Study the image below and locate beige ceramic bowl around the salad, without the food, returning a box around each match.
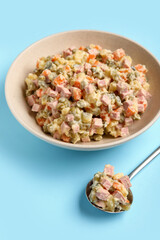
[5,30,160,150]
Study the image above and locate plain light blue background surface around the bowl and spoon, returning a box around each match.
[0,0,160,240]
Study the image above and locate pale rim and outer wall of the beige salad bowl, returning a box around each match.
[5,29,160,151]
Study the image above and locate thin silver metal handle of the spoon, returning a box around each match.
[128,147,160,180]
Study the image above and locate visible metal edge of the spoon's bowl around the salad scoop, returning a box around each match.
[86,179,133,213]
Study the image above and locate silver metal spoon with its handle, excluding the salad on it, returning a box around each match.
[86,147,160,213]
